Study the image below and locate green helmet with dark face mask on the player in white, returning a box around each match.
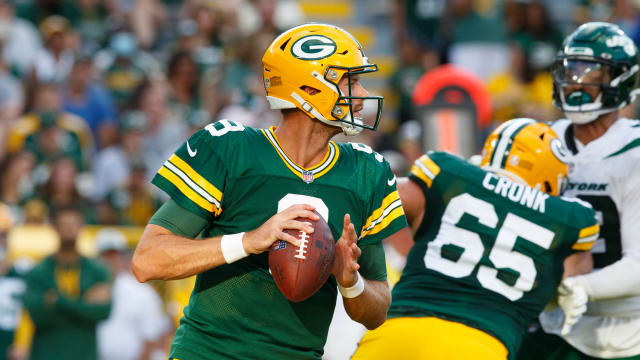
[552,22,640,124]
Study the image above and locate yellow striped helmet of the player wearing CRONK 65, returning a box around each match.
[480,118,569,195]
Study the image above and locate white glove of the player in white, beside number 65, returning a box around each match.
[558,276,589,335]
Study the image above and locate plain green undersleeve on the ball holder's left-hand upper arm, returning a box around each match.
[149,199,208,239]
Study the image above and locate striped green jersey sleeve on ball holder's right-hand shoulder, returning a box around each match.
[352,144,407,246]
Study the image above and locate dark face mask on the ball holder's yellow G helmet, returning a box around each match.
[324,64,384,130]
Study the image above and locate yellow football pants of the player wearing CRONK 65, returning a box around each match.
[351,317,508,360]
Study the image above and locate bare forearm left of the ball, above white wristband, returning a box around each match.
[131,224,226,282]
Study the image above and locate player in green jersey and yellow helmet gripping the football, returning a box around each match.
[132,24,408,360]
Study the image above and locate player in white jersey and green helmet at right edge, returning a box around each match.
[519,22,640,359]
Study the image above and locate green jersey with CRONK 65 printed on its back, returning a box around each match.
[389,152,598,357]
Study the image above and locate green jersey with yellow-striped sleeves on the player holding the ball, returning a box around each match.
[153,120,407,360]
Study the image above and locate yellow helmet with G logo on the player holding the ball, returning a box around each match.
[262,24,382,135]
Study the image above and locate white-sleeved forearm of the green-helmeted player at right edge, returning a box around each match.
[580,254,640,300]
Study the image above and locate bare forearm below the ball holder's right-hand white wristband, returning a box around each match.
[343,279,391,330]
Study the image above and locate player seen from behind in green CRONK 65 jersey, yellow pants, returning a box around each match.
[353,119,598,360]
